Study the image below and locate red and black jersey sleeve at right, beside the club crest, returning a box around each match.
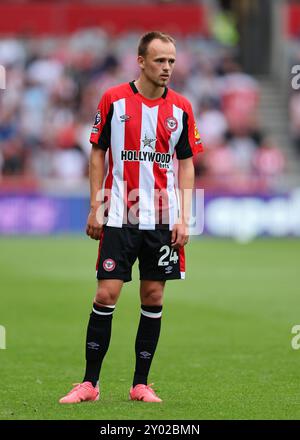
[175,105,203,160]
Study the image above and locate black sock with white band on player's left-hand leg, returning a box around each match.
[83,303,115,386]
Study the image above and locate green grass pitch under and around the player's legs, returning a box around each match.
[0,237,300,420]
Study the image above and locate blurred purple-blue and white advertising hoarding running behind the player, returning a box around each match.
[0,189,300,241]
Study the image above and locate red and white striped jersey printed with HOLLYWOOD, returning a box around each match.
[90,82,202,230]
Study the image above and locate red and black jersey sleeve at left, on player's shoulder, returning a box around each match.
[90,93,113,151]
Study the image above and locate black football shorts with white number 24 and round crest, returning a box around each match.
[96,226,185,282]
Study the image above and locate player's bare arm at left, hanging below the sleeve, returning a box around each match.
[86,144,105,240]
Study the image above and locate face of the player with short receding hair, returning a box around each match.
[138,39,176,87]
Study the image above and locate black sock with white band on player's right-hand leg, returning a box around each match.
[133,305,162,386]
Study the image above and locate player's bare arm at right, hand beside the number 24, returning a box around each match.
[172,157,195,248]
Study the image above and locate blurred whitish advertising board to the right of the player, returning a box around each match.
[204,189,300,241]
